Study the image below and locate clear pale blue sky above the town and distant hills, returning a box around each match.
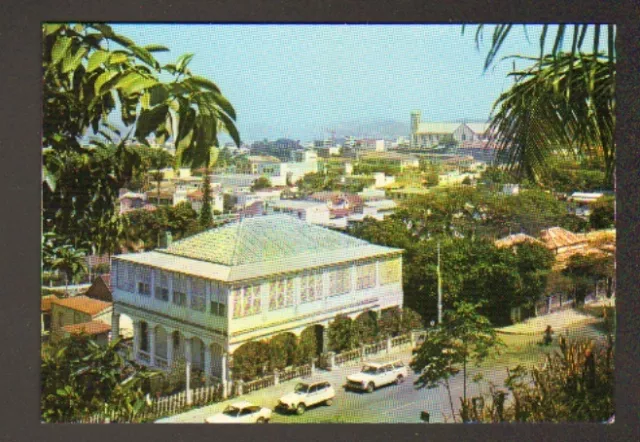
[113,24,556,142]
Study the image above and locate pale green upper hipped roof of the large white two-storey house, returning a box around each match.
[158,215,380,266]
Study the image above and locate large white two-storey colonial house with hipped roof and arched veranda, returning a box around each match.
[112,215,403,387]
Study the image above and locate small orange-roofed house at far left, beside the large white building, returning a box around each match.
[51,295,113,343]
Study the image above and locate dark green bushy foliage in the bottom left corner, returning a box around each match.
[40,335,153,422]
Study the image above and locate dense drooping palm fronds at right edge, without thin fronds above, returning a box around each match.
[491,53,615,186]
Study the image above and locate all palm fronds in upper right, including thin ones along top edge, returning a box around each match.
[463,24,616,185]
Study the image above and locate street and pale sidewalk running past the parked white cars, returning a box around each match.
[156,312,603,423]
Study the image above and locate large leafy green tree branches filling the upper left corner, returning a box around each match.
[42,23,240,253]
